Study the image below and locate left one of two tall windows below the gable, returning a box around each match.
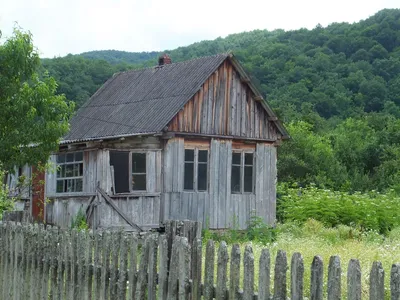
[183,149,208,192]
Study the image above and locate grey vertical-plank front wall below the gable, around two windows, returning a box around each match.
[162,138,276,229]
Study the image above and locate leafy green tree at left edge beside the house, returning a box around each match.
[0,29,74,169]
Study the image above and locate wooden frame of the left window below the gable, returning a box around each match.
[183,146,210,193]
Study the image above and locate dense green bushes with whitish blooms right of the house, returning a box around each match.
[278,185,400,234]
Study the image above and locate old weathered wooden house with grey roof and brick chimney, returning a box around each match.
[7,54,287,229]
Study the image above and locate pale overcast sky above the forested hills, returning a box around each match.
[0,0,400,57]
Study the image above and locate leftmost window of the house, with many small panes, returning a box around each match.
[56,152,83,193]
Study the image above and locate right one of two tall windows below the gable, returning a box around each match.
[231,152,254,193]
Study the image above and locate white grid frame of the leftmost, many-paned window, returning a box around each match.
[55,151,85,195]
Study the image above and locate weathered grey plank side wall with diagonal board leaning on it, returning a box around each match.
[46,137,162,228]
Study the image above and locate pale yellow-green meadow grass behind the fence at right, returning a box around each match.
[204,220,400,299]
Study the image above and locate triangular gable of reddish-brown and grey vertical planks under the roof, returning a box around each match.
[168,60,278,140]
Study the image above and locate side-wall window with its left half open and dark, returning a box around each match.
[110,151,147,193]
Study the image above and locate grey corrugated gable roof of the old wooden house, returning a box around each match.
[61,53,287,144]
